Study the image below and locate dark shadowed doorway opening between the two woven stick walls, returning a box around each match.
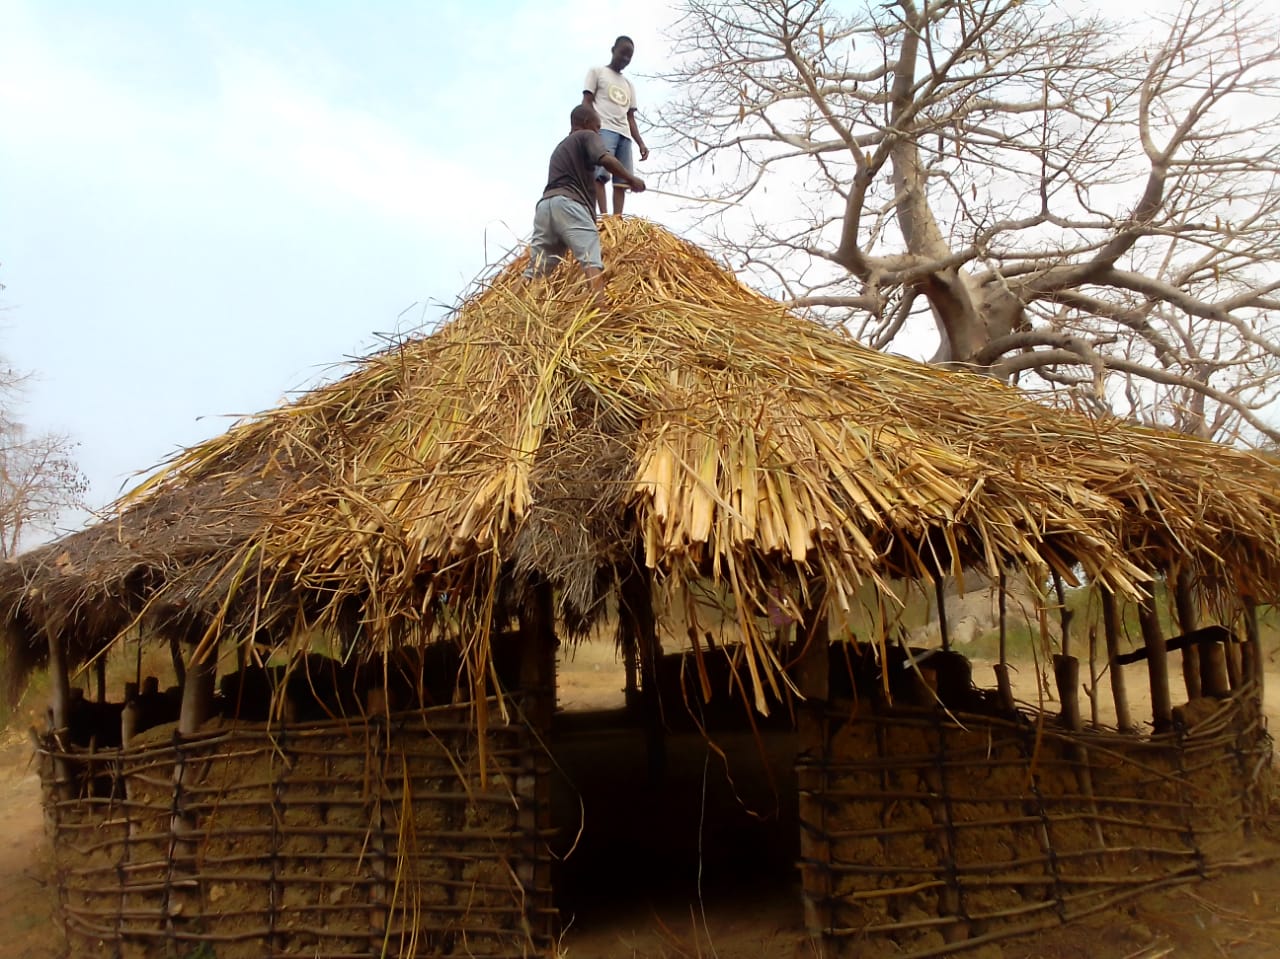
[552,711,801,928]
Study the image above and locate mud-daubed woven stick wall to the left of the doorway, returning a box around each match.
[41,705,554,959]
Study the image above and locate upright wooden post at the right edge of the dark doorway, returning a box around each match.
[795,599,833,949]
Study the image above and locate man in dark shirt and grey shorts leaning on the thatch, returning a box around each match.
[525,105,644,300]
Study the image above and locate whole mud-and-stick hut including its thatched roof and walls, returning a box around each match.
[0,219,1280,956]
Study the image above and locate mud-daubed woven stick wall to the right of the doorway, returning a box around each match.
[799,689,1271,959]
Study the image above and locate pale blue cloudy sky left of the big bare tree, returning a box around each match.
[0,0,696,530]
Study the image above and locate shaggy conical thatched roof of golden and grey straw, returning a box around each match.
[0,219,1280,696]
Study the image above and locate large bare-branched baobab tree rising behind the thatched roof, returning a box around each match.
[662,0,1280,439]
